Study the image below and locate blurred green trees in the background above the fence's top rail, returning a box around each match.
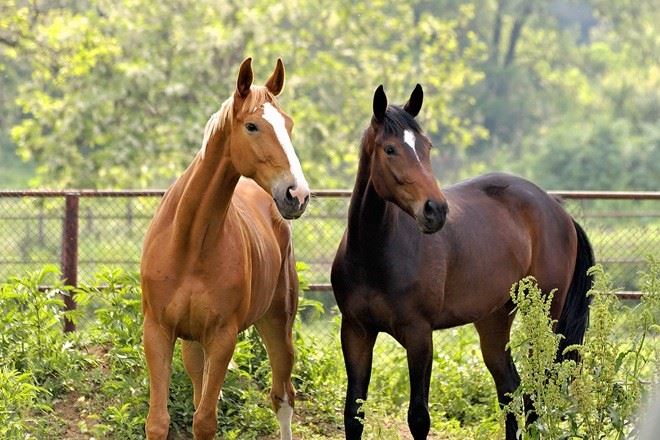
[0,0,660,189]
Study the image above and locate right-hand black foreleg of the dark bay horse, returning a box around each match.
[404,328,433,440]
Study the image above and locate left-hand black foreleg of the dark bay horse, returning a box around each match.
[341,319,377,440]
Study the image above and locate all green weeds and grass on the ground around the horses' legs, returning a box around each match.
[0,259,660,439]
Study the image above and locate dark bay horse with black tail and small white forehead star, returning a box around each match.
[332,85,593,440]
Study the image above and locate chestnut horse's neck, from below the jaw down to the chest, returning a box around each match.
[173,124,240,251]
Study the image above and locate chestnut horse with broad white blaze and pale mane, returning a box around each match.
[141,58,309,439]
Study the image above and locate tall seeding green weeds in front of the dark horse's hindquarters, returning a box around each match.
[507,259,660,439]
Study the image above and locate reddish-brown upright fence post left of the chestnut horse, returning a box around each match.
[60,193,79,332]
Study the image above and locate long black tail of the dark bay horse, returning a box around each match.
[555,220,594,362]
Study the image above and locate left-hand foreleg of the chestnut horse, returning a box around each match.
[144,315,175,440]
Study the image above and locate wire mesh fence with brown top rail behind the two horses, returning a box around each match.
[0,190,660,312]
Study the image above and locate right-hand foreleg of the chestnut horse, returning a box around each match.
[193,325,238,440]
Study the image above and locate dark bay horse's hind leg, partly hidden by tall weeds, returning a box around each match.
[474,302,535,440]
